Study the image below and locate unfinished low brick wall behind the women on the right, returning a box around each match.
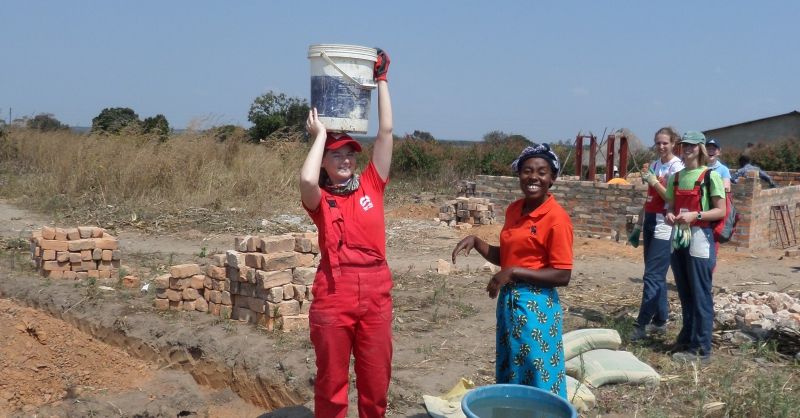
[475,172,800,249]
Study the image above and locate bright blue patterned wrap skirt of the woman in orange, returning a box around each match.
[496,283,567,399]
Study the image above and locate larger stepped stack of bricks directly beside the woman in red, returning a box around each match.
[155,233,319,331]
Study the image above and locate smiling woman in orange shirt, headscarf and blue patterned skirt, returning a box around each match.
[452,144,573,399]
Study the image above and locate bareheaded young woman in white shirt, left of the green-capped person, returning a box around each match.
[630,127,683,341]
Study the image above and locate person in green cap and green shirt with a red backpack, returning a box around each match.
[665,131,725,363]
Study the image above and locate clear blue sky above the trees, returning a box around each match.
[0,0,800,141]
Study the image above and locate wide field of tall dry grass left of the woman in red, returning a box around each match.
[0,130,307,229]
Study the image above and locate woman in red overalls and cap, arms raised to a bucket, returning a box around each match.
[300,49,393,418]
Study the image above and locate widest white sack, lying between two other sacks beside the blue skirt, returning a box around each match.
[566,349,661,387]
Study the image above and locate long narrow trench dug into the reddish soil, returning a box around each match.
[7,298,304,411]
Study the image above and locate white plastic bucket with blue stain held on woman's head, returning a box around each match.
[308,44,378,134]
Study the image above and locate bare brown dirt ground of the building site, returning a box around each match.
[0,201,800,418]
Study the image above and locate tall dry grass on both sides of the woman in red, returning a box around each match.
[0,129,458,232]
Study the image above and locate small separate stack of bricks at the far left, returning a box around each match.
[30,226,121,280]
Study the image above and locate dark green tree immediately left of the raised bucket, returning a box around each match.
[247,91,309,141]
